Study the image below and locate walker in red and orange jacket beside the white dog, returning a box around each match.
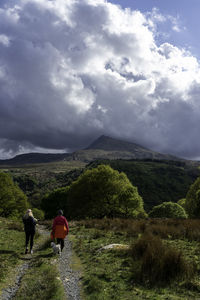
[51,209,69,251]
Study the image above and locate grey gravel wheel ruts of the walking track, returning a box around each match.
[0,225,82,300]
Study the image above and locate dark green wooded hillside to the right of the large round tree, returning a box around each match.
[88,160,200,212]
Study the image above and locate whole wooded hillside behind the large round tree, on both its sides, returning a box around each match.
[6,156,200,211]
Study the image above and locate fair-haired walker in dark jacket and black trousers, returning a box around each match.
[22,209,37,254]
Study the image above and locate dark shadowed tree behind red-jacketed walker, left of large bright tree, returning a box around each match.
[41,187,69,219]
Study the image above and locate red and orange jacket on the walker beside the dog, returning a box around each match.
[52,216,69,239]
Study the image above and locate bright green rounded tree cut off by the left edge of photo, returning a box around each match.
[0,173,28,217]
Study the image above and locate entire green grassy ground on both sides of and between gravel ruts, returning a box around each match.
[0,218,200,300]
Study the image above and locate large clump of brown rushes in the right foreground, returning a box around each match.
[130,234,195,286]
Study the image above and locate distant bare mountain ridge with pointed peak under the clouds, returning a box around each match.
[0,135,189,166]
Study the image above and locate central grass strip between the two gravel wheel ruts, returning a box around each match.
[14,238,65,300]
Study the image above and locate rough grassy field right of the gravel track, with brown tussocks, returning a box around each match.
[71,219,200,300]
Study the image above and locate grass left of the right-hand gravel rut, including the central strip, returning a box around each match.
[0,218,65,300]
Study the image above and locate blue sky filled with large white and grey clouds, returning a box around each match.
[0,0,200,159]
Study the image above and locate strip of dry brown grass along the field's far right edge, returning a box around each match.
[76,218,200,241]
